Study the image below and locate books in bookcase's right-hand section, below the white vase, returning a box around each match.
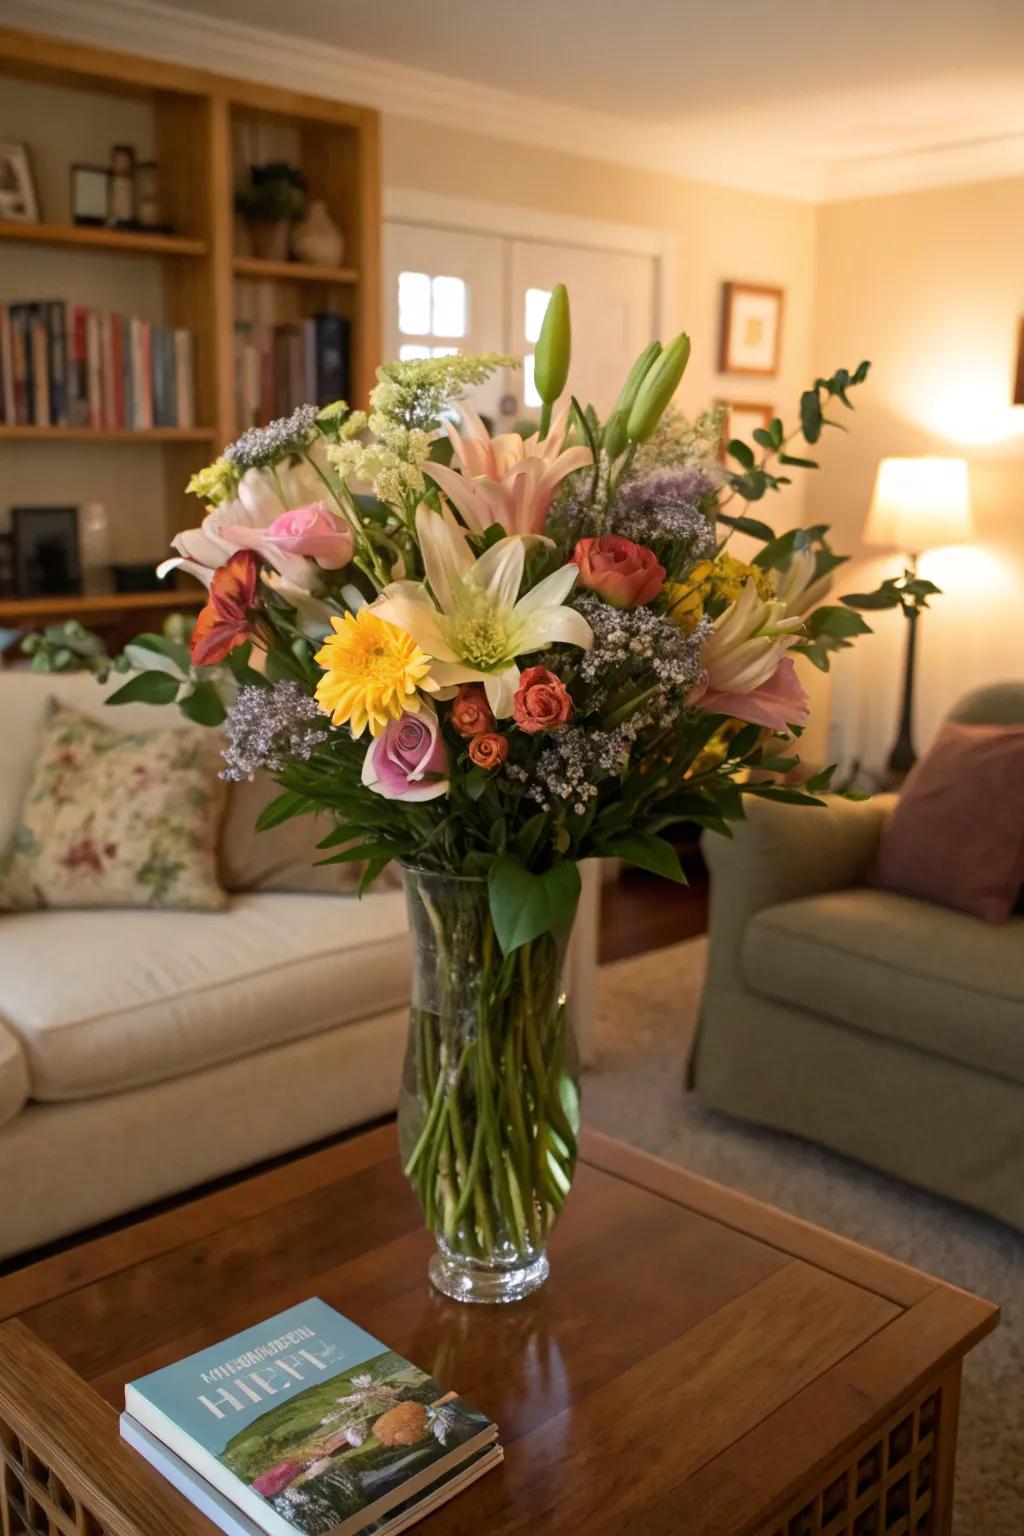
[235,315,350,427]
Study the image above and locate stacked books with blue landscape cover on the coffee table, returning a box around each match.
[121,1299,502,1536]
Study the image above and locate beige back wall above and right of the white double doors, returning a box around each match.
[382,117,815,527]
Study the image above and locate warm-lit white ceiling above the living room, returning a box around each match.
[16,0,1024,200]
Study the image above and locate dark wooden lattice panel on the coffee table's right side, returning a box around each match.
[758,1376,958,1536]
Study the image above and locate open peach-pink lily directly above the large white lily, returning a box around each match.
[422,401,593,533]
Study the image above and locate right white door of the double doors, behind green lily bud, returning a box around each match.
[507,240,656,419]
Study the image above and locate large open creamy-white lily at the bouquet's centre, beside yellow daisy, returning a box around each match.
[373,505,594,720]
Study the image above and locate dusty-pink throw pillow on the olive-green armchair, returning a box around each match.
[874,720,1024,923]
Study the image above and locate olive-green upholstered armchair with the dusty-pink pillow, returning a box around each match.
[691,684,1024,1229]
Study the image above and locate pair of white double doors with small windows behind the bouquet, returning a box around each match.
[384,221,657,422]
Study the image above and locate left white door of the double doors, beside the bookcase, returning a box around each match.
[382,223,508,416]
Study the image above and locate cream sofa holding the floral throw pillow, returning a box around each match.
[0,671,599,1258]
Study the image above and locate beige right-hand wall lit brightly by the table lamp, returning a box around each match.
[808,180,1024,763]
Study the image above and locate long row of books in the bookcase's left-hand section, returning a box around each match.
[0,300,195,430]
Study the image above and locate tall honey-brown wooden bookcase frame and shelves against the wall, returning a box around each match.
[0,28,381,621]
